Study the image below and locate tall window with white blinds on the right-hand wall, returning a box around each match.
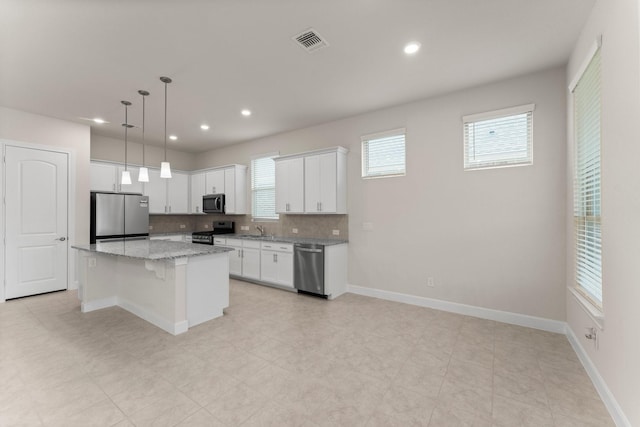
[573,49,602,307]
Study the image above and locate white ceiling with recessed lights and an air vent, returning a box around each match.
[0,0,595,152]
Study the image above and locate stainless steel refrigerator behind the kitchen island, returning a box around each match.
[90,191,149,243]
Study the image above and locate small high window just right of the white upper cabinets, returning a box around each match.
[361,129,406,178]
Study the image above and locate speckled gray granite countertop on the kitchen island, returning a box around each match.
[71,239,232,261]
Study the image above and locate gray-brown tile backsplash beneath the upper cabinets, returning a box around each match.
[149,215,349,239]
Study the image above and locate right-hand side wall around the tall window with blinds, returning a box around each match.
[566,0,640,425]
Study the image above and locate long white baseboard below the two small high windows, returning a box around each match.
[347,285,566,334]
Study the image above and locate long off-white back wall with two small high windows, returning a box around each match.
[195,68,566,321]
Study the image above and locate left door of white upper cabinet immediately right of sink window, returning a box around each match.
[275,157,304,213]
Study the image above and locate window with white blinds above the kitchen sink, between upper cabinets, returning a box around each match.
[251,154,278,219]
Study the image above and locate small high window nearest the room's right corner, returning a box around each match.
[462,104,535,170]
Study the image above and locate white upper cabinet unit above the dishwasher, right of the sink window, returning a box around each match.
[275,147,347,214]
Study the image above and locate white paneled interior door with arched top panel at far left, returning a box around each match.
[5,146,69,299]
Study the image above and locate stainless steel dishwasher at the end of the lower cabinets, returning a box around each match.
[293,243,324,296]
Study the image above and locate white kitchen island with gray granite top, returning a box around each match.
[72,239,231,335]
